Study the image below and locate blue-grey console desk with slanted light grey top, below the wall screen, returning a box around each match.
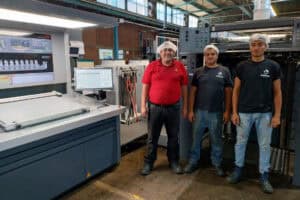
[0,92,125,199]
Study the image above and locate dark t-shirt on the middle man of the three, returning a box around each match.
[192,66,232,112]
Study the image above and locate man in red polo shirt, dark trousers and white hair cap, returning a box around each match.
[141,41,188,175]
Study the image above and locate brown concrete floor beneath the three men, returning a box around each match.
[59,146,300,200]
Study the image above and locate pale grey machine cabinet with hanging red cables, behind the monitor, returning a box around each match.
[96,60,149,145]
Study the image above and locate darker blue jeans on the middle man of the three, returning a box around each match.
[189,109,223,166]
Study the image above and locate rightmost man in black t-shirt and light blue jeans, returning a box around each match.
[228,34,282,193]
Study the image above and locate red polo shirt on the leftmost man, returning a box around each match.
[142,60,188,105]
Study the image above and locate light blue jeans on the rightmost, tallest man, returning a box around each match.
[235,113,272,174]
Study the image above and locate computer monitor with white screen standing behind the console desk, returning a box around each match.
[74,68,113,91]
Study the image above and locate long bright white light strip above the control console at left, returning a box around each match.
[0,8,96,29]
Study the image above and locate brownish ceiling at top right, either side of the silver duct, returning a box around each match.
[166,0,300,24]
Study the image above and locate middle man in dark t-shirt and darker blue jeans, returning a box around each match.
[184,45,232,176]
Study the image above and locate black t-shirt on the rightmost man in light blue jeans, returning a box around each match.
[236,59,281,113]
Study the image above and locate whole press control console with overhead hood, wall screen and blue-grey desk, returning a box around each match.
[0,0,125,200]
